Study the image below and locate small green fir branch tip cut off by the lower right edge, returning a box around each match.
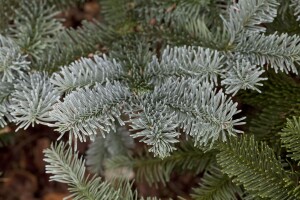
[280,117,300,165]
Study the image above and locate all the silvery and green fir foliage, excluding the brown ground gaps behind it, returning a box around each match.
[0,0,300,200]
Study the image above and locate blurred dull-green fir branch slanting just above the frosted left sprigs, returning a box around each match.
[33,21,117,72]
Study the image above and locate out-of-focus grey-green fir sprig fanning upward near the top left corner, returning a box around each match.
[10,0,63,60]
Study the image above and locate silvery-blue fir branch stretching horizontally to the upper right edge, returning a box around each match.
[234,33,300,74]
